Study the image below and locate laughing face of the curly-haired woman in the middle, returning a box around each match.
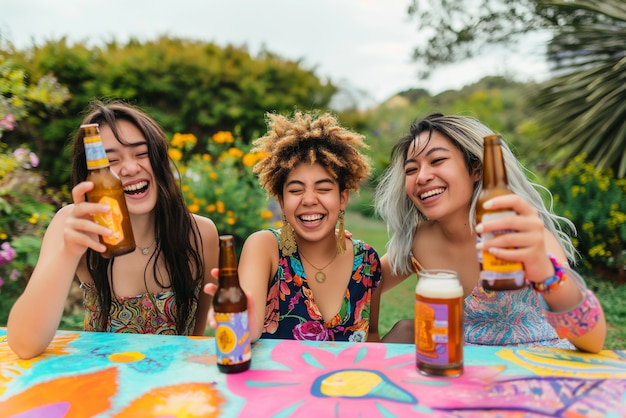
[280,163,350,241]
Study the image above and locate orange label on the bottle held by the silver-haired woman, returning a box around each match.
[478,211,524,286]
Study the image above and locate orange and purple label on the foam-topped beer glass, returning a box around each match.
[415,301,450,365]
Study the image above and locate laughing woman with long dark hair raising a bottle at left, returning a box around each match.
[7,101,219,358]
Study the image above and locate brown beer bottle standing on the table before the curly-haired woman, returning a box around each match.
[213,235,252,373]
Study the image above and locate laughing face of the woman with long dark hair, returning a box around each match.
[100,120,157,214]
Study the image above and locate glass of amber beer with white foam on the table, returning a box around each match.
[415,270,463,377]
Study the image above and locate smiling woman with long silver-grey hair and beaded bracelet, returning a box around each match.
[372,114,606,352]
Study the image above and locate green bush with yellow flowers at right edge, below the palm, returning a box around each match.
[547,155,626,280]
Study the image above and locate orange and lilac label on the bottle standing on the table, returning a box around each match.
[215,311,252,366]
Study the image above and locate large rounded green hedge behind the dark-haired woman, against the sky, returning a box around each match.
[0,36,337,187]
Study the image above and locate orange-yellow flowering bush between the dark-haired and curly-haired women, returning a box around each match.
[170,126,278,245]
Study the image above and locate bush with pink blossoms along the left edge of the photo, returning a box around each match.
[0,55,68,325]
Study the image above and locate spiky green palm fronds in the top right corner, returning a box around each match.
[536,0,626,178]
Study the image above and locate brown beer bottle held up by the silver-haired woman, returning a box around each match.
[476,135,524,290]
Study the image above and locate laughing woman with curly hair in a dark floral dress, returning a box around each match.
[207,112,381,341]
